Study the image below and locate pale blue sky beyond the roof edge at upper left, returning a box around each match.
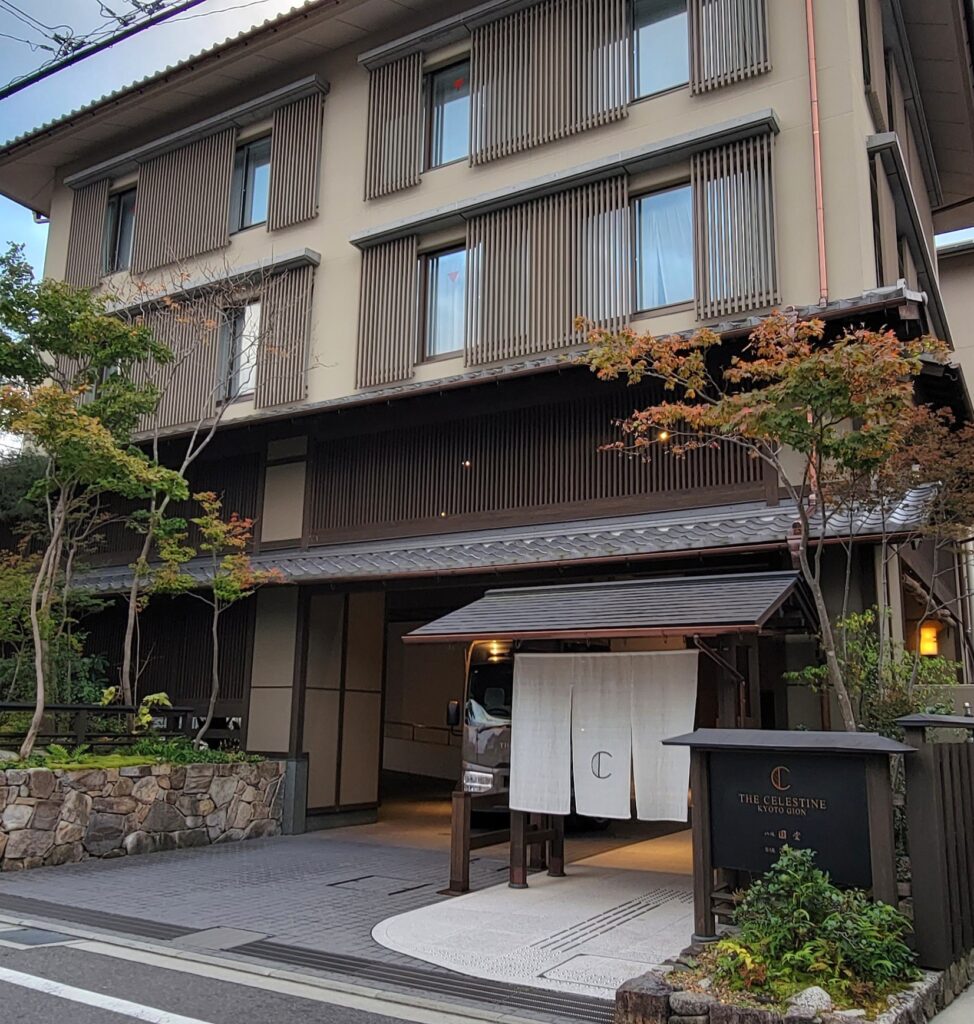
[0,0,301,274]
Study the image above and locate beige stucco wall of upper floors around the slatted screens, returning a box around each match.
[36,0,905,419]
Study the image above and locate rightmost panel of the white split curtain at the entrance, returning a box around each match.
[632,650,700,821]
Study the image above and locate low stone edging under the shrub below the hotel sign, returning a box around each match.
[615,953,974,1024]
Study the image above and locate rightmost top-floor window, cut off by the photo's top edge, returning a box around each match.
[633,0,690,99]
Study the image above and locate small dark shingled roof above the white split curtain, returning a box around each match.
[403,572,799,643]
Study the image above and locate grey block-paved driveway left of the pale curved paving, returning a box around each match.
[0,833,507,966]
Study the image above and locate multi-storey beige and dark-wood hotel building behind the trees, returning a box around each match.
[0,0,974,814]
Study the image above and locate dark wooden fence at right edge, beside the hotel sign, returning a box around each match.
[899,715,974,970]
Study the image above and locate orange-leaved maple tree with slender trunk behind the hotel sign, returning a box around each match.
[579,311,974,730]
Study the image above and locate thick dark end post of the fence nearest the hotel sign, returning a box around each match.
[904,727,954,971]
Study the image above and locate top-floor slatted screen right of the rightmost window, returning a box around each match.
[689,0,771,93]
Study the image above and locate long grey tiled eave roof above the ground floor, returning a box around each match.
[84,493,923,593]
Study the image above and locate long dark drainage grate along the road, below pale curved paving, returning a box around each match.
[234,941,615,1024]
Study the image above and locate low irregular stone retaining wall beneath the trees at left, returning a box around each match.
[0,761,284,871]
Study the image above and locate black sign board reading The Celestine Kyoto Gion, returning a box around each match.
[709,750,872,889]
